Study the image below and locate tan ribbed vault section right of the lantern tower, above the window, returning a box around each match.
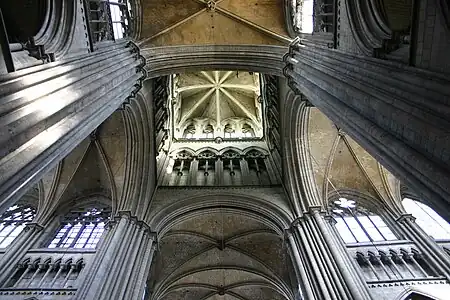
[308,108,401,211]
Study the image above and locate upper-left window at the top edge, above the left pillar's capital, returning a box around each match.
[86,0,131,43]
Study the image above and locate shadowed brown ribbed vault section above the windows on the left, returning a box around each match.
[31,111,126,222]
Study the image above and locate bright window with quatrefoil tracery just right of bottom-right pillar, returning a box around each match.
[332,197,397,243]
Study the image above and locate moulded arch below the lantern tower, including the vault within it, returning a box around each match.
[149,191,294,300]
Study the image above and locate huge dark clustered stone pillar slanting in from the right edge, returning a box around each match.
[284,40,450,221]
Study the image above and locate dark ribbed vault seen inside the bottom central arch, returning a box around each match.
[149,209,293,300]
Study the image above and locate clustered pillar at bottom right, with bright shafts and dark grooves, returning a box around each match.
[292,208,372,300]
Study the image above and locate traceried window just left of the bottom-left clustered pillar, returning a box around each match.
[48,207,111,249]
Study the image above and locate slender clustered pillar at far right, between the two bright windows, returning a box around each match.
[396,214,450,280]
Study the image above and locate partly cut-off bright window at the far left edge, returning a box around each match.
[0,204,36,248]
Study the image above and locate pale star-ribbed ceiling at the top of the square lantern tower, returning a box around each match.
[172,71,263,138]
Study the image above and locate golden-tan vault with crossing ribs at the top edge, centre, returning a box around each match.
[140,0,290,48]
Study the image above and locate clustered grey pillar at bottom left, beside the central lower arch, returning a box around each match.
[75,212,156,300]
